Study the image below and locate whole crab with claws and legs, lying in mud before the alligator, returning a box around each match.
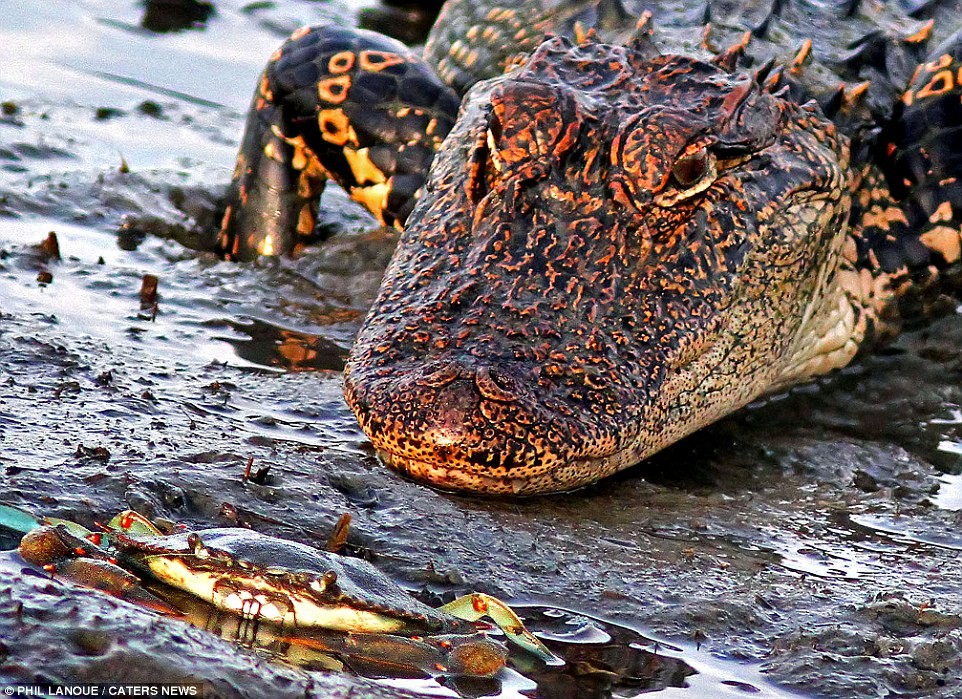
[0,505,563,675]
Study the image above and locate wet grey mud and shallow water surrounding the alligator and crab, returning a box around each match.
[0,0,962,699]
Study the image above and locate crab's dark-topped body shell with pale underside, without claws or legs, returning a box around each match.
[111,528,468,634]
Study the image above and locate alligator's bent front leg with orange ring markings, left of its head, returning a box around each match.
[217,26,459,260]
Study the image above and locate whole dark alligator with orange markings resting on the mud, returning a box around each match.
[219,0,962,495]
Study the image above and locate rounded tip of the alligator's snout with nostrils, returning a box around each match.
[345,361,608,494]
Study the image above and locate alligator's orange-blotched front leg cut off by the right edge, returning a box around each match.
[849,31,962,340]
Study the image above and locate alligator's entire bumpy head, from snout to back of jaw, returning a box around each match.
[345,38,858,493]
